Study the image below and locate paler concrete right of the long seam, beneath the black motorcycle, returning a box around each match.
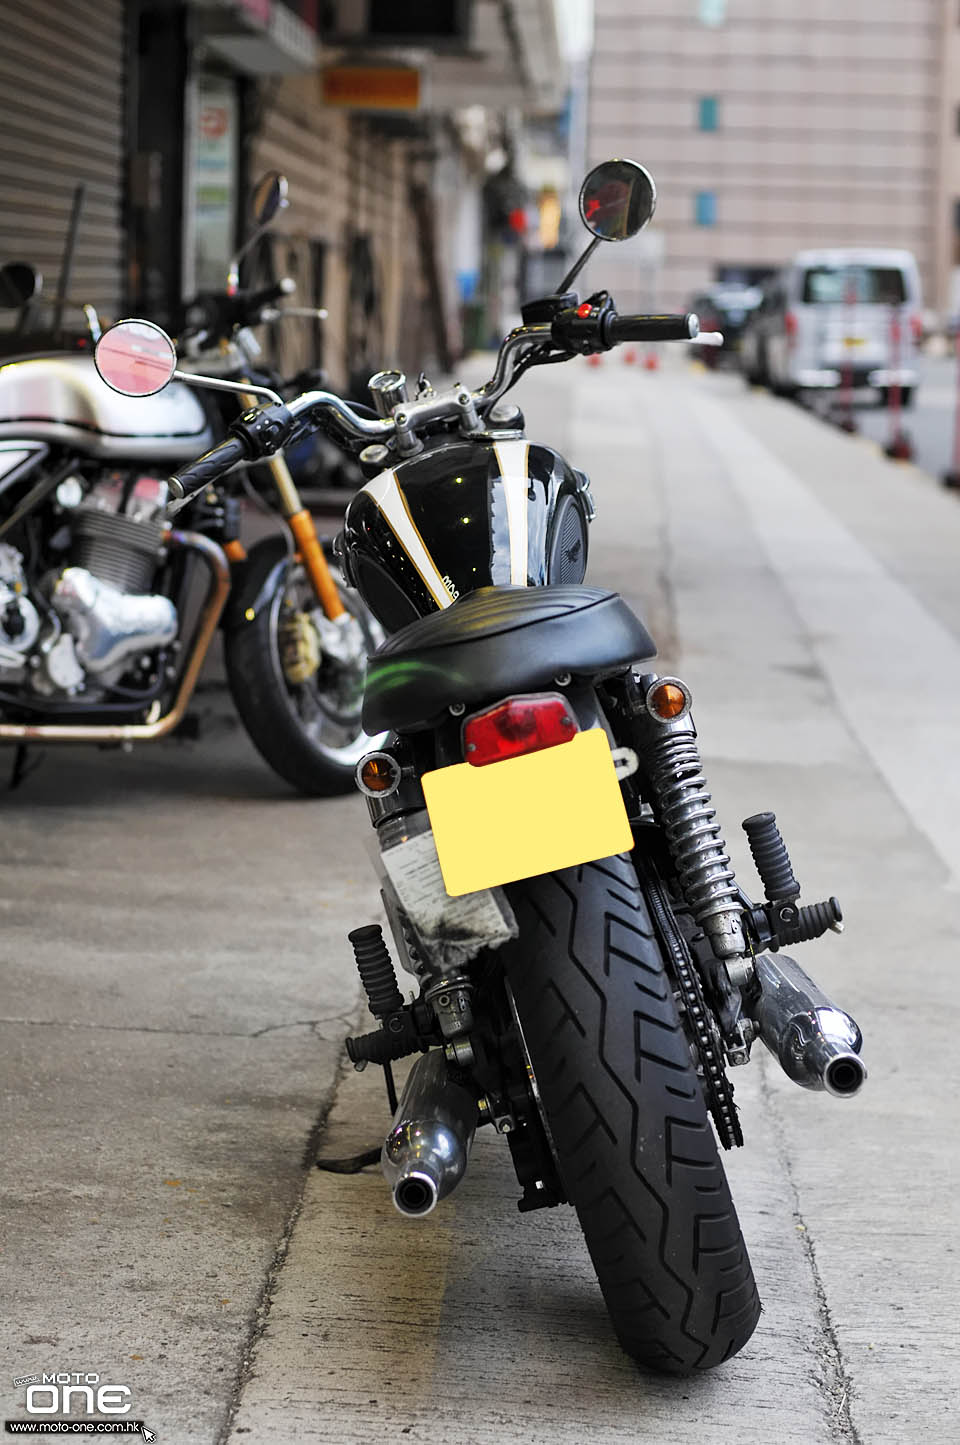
[222,360,960,1445]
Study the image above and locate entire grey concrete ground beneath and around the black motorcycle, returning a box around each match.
[0,358,960,1445]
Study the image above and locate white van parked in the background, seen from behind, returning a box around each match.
[742,247,922,406]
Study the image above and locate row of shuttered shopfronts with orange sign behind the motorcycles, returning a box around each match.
[0,0,564,394]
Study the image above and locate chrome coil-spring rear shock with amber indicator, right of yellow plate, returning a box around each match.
[640,676,746,958]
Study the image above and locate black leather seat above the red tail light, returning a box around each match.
[363,587,656,733]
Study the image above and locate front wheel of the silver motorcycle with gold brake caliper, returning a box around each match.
[224,548,383,798]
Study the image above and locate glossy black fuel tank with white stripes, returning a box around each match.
[336,439,593,631]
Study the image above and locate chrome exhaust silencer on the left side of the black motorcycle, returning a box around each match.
[380,1049,479,1217]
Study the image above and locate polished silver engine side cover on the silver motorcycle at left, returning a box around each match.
[51,566,178,676]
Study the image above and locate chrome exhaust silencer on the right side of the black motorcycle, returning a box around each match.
[747,954,866,1098]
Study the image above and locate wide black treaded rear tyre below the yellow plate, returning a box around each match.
[503,857,760,1374]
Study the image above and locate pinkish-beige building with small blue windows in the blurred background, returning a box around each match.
[588,0,960,311]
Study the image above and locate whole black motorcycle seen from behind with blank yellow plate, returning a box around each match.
[93,160,866,1374]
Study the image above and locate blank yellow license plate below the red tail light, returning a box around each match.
[422,728,633,897]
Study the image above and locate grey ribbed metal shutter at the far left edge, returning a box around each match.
[0,0,124,327]
